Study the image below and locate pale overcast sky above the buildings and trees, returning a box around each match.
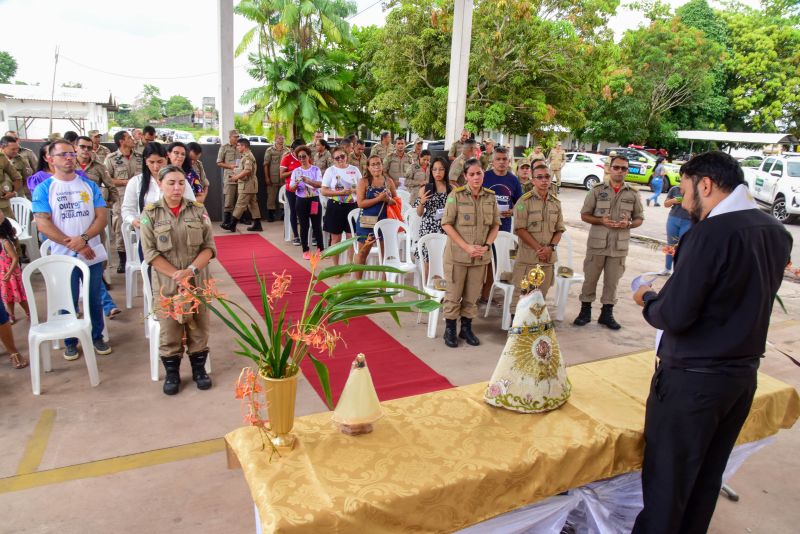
[0,0,758,111]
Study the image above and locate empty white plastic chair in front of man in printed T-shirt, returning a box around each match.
[22,255,100,395]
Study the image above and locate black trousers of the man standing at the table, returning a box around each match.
[633,365,756,534]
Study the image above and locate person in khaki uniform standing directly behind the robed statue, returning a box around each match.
[511,162,567,311]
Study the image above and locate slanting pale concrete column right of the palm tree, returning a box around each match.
[444,0,472,150]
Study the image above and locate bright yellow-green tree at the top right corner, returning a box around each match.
[720,4,800,133]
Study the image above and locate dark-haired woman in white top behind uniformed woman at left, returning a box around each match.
[121,141,195,228]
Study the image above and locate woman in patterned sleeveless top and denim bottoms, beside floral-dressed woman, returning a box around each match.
[354,155,397,280]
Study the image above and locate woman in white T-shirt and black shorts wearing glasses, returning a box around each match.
[322,147,361,265]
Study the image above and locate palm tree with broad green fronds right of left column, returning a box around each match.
[235,0,356,136]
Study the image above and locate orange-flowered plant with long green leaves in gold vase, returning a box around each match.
[161,238,440,408]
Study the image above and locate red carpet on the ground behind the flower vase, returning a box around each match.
[215,235,453,404]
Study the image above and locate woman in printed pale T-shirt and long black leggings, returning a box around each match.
[287,146,325,260]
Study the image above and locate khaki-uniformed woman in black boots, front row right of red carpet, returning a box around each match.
[442,161,500,347]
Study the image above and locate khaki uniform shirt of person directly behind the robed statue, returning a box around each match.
[514,191,567,265]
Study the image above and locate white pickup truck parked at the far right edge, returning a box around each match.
[743,152,800,224]
